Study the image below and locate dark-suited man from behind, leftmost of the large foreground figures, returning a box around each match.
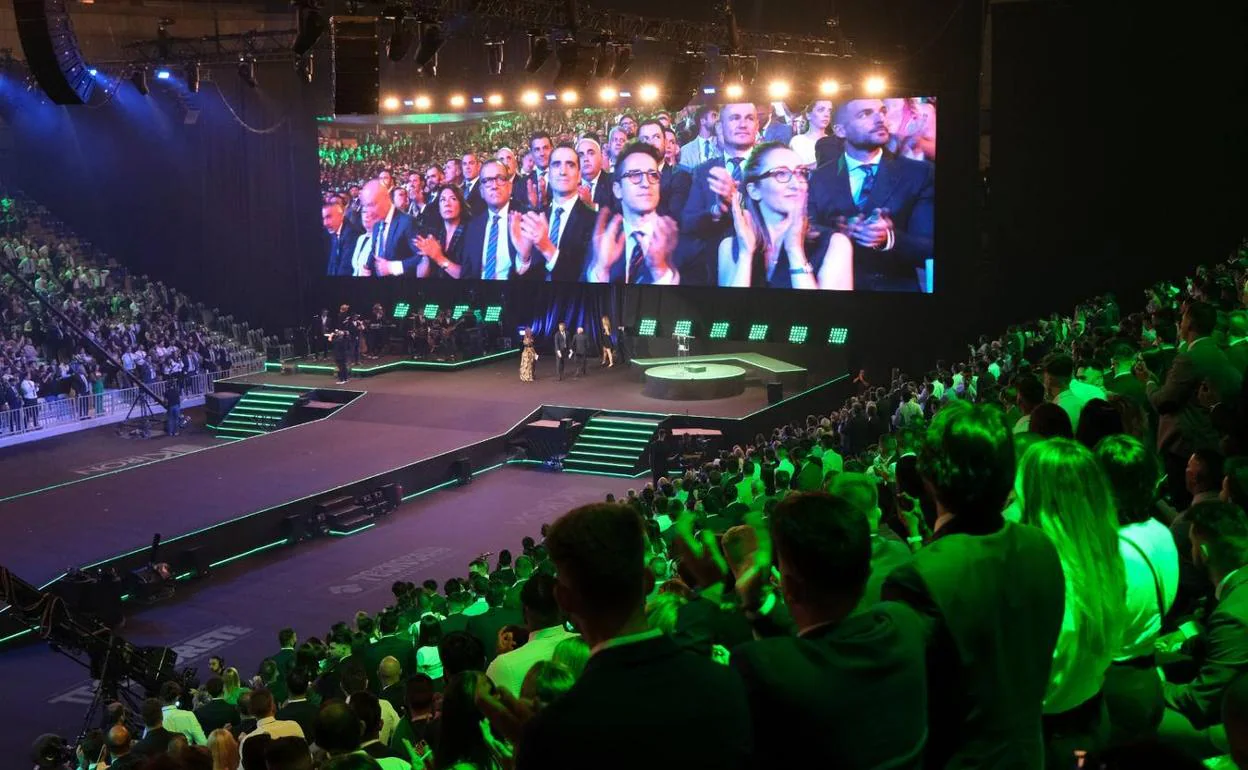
[506,503,750,770]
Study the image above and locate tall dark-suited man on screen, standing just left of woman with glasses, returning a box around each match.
[676,102,759,286]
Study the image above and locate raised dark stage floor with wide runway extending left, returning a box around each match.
[0,357,766,585]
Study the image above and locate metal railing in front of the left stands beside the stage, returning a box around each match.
[0,357,265,439]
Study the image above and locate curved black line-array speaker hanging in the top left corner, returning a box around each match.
[12,0,95,105]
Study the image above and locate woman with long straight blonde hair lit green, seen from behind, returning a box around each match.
[1002,438,1127,768]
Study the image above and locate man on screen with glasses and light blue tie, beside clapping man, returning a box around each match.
[459,161,536,281]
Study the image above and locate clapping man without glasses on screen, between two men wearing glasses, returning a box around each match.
[517,144,594,282]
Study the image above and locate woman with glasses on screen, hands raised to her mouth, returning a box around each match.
[719,142,854,291]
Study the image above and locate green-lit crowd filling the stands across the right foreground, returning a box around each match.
[68,239,1248,770]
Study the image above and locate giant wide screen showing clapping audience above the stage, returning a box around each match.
[319,97,936,292]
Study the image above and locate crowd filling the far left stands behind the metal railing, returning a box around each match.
[0,192,260,433]
